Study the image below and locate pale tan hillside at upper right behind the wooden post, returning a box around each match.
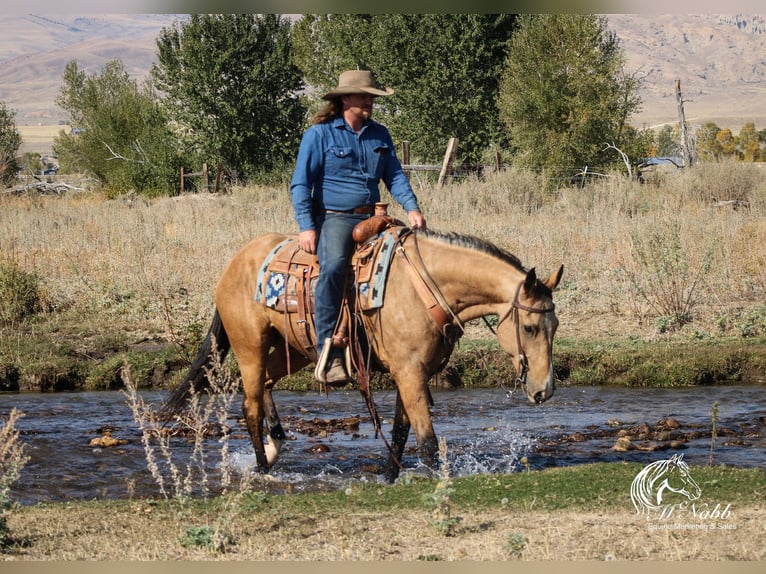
[608,14,766,133]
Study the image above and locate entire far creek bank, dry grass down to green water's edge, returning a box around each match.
[0,164,766,390]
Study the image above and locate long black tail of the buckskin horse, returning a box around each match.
[161,309,231,417]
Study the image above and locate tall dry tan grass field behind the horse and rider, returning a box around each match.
[0,164,766,346]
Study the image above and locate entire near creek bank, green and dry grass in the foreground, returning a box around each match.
[4,463,766,561]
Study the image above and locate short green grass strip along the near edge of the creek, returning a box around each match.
[146,463,766,518]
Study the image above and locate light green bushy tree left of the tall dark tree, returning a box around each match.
[54,60,180,193]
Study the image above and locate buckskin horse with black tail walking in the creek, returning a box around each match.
[164,228,564,482]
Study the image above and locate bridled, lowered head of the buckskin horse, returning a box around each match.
[497,265,564,403]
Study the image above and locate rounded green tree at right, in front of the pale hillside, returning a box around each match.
[500,14,640,180]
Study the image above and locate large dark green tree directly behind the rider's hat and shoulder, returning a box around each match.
[293,14,515,162]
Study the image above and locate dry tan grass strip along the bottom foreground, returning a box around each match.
[5,501,766,561]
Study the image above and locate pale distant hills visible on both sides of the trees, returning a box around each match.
[0,14,766,134]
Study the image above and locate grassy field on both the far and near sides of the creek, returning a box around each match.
[0,164,766,562]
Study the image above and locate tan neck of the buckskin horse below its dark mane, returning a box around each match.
[418,238,526,322]
